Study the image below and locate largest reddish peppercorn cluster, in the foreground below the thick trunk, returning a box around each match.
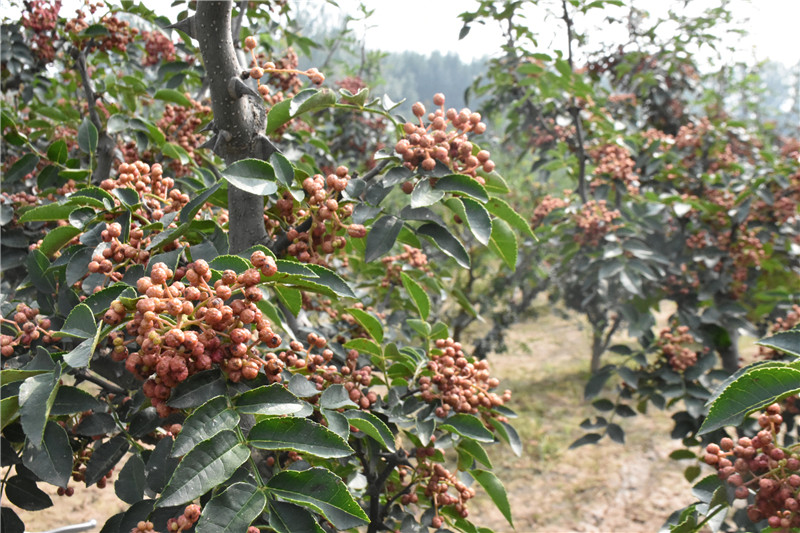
[103,251,282,416]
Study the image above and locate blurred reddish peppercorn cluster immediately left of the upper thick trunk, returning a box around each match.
[156,97,212,177]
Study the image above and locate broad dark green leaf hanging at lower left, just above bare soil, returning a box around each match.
[22,421,72,487]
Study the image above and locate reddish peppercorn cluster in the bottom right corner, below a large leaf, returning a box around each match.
[705,404,800,533]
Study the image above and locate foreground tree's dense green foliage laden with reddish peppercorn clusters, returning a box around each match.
[0,2,526,533]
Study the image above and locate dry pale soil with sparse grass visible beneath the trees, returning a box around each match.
[9,306,704,533]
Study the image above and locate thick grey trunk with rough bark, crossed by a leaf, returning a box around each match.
[190,1,274,253]
